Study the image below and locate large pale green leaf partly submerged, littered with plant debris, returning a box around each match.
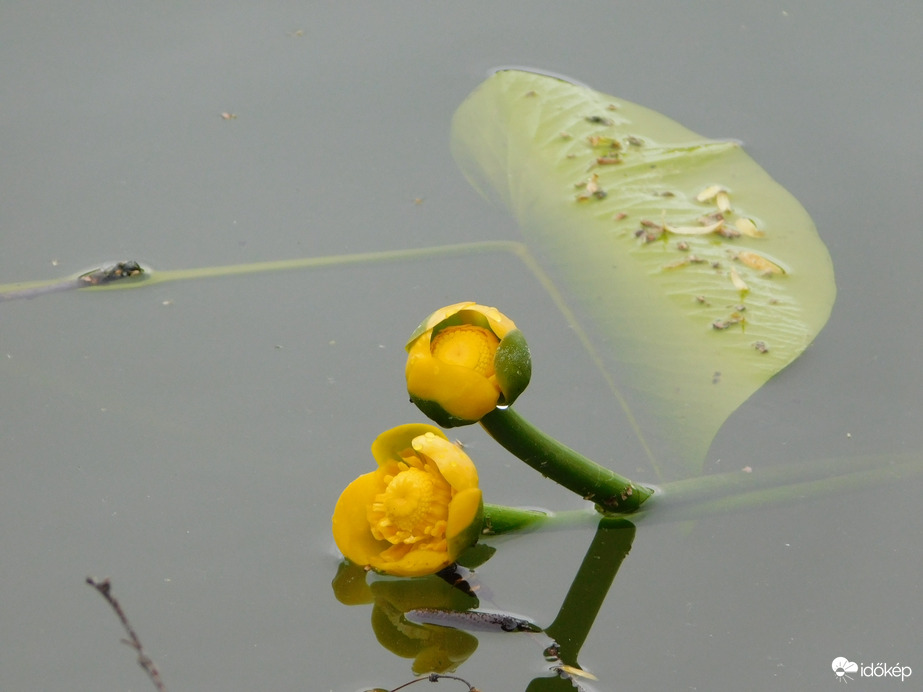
[452,70,836,476]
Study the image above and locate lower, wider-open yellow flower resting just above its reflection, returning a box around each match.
[333,424,483,577]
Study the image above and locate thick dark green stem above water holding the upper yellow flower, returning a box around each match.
[481,408,654,514]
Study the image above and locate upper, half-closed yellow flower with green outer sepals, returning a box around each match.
[406,302,532,428]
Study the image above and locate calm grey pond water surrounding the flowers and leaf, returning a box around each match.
[0,1,923,692]
